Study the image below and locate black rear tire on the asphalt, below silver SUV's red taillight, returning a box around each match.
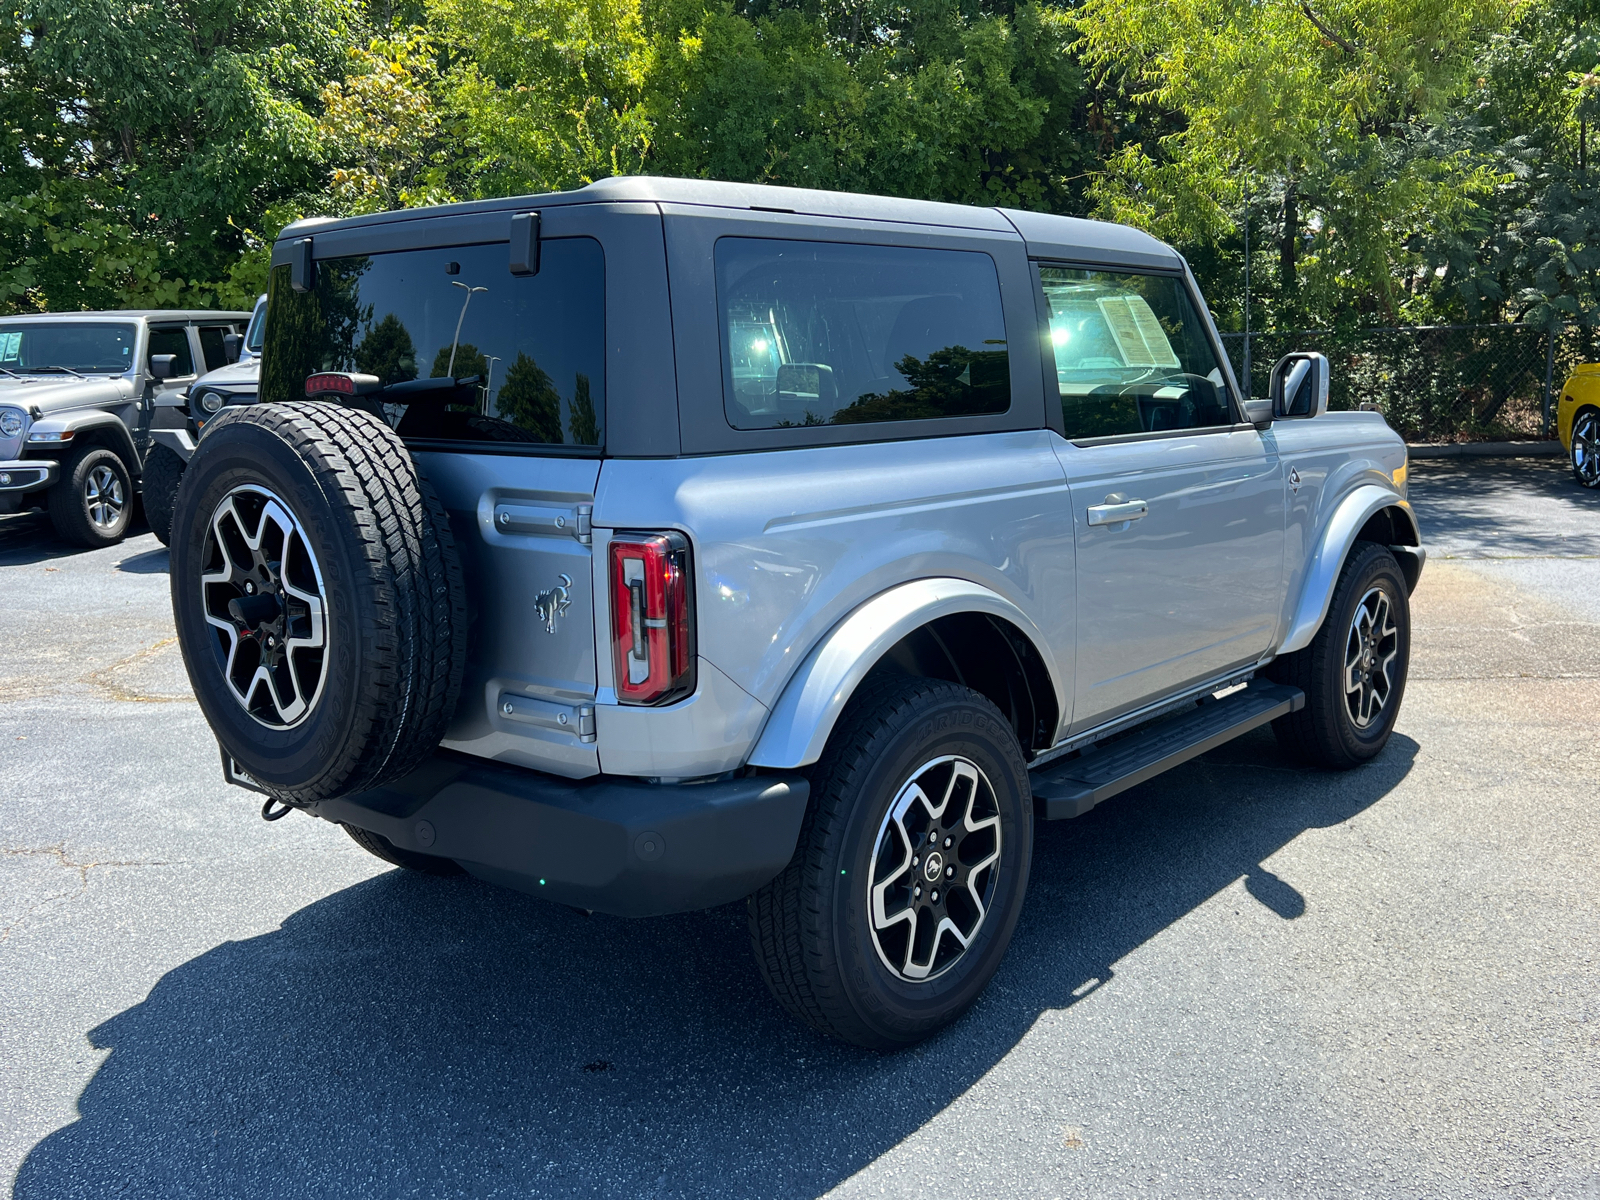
[747,677,1034,1050]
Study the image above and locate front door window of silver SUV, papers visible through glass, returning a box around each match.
[1040,267,1234,438]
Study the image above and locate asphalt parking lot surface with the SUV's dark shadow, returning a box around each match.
[0,459,1600,1200]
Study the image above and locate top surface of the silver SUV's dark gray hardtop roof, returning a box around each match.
[278,174,1182,267]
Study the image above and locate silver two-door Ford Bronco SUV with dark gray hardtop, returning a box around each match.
[171,178,1422,1046]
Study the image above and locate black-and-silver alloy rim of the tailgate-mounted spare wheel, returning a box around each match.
[200,485,328,728]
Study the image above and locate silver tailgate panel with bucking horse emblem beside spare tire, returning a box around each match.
[416,451,600,779]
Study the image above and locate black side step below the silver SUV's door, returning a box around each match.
[1030,680,1306,821]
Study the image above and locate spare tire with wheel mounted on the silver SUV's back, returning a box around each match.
[170,402,467,805]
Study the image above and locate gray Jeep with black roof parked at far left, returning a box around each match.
[0,309,250,547]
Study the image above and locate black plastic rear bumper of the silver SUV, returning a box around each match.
[309,754,810,917]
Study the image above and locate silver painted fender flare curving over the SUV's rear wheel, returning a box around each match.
[749,578,1067,770]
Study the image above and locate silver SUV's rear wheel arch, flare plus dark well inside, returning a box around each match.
[749,579,1066,770]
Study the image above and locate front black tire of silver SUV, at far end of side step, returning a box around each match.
[1267,542,1411,770]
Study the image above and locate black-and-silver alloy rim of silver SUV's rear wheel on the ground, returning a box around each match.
[867,755,1000,982]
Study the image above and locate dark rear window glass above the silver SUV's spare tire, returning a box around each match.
[261,237,605,448]
